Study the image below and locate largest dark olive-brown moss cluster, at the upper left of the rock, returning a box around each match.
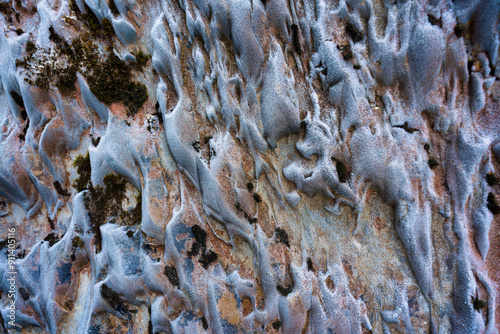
[16,10,151,116]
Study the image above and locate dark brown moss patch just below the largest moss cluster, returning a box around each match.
[73,153,142,252]
